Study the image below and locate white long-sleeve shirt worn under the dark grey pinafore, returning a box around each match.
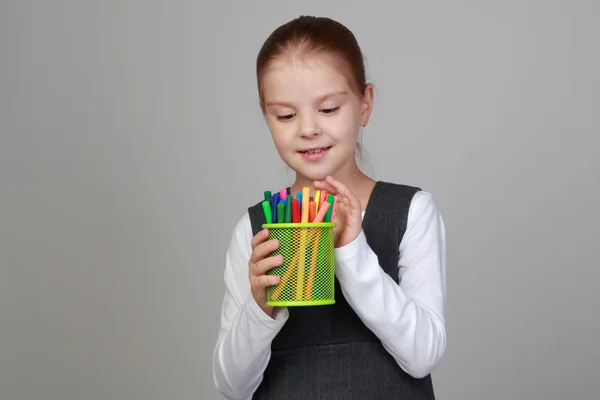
[213,191,446,400]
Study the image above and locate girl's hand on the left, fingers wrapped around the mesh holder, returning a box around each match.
[248,229,283,318]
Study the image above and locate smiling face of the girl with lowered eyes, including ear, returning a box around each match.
[262,54,372,181]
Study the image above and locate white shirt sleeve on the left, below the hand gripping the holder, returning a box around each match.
[213,214,289,400]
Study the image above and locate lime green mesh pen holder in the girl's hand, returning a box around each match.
[263,222,335,307]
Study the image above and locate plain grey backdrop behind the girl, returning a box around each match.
[0,0,600,400]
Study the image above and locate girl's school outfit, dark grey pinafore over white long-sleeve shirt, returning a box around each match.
[213,181,446,400]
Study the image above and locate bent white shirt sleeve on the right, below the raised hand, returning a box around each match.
[335,191,446,378]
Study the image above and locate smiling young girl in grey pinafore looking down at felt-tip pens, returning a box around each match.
[213,17,446,400]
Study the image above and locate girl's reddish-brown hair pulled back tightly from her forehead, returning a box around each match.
[256,16,367,162]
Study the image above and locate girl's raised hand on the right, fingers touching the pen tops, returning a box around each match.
[314,176,362,248]
